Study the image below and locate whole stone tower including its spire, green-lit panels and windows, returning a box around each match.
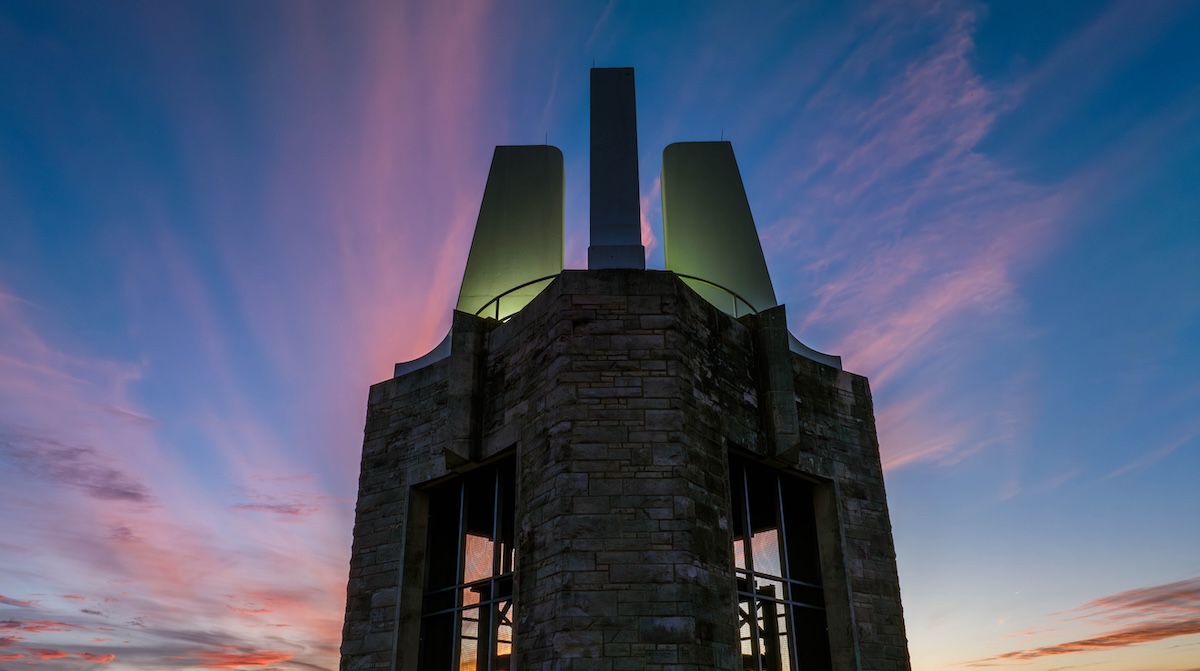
[342,68,910,671]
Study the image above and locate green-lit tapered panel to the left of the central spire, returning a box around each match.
[456,145,563,319]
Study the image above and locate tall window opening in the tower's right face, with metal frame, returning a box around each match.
[730,457,830,671]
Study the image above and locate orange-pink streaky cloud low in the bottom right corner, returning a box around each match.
[966,577,1200,666]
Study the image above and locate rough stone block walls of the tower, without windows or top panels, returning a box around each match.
[342,270,908,671]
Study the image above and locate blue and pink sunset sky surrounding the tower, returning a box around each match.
[0,0,1200,671]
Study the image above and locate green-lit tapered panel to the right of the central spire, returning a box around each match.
[661,142,778,316]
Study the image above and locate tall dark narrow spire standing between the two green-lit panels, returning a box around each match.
[588,67,646,270]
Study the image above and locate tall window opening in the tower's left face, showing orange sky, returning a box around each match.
[420,459,516,671]
